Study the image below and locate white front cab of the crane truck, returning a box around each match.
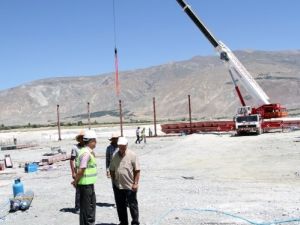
[234,106,262,135]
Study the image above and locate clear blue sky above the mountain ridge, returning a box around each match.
[0,0,300,90]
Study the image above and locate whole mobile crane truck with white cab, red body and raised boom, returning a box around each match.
[177,0,288,134]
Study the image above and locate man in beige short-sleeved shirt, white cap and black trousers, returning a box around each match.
[110,137,140,225]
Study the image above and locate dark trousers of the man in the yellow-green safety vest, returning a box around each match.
[78,184,96,225]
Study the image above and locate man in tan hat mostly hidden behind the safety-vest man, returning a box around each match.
[70,131,84,214]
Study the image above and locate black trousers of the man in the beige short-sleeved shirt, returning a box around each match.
[113,185,140,225]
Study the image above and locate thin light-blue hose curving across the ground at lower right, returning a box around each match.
[153,208,300,225]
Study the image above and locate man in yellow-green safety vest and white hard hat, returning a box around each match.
[72,130,97,225]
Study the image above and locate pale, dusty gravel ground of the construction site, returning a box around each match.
[0,127,300,225]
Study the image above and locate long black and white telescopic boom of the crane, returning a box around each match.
[177,0,270,104]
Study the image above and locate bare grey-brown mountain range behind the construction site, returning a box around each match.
[0,50,300,125]
